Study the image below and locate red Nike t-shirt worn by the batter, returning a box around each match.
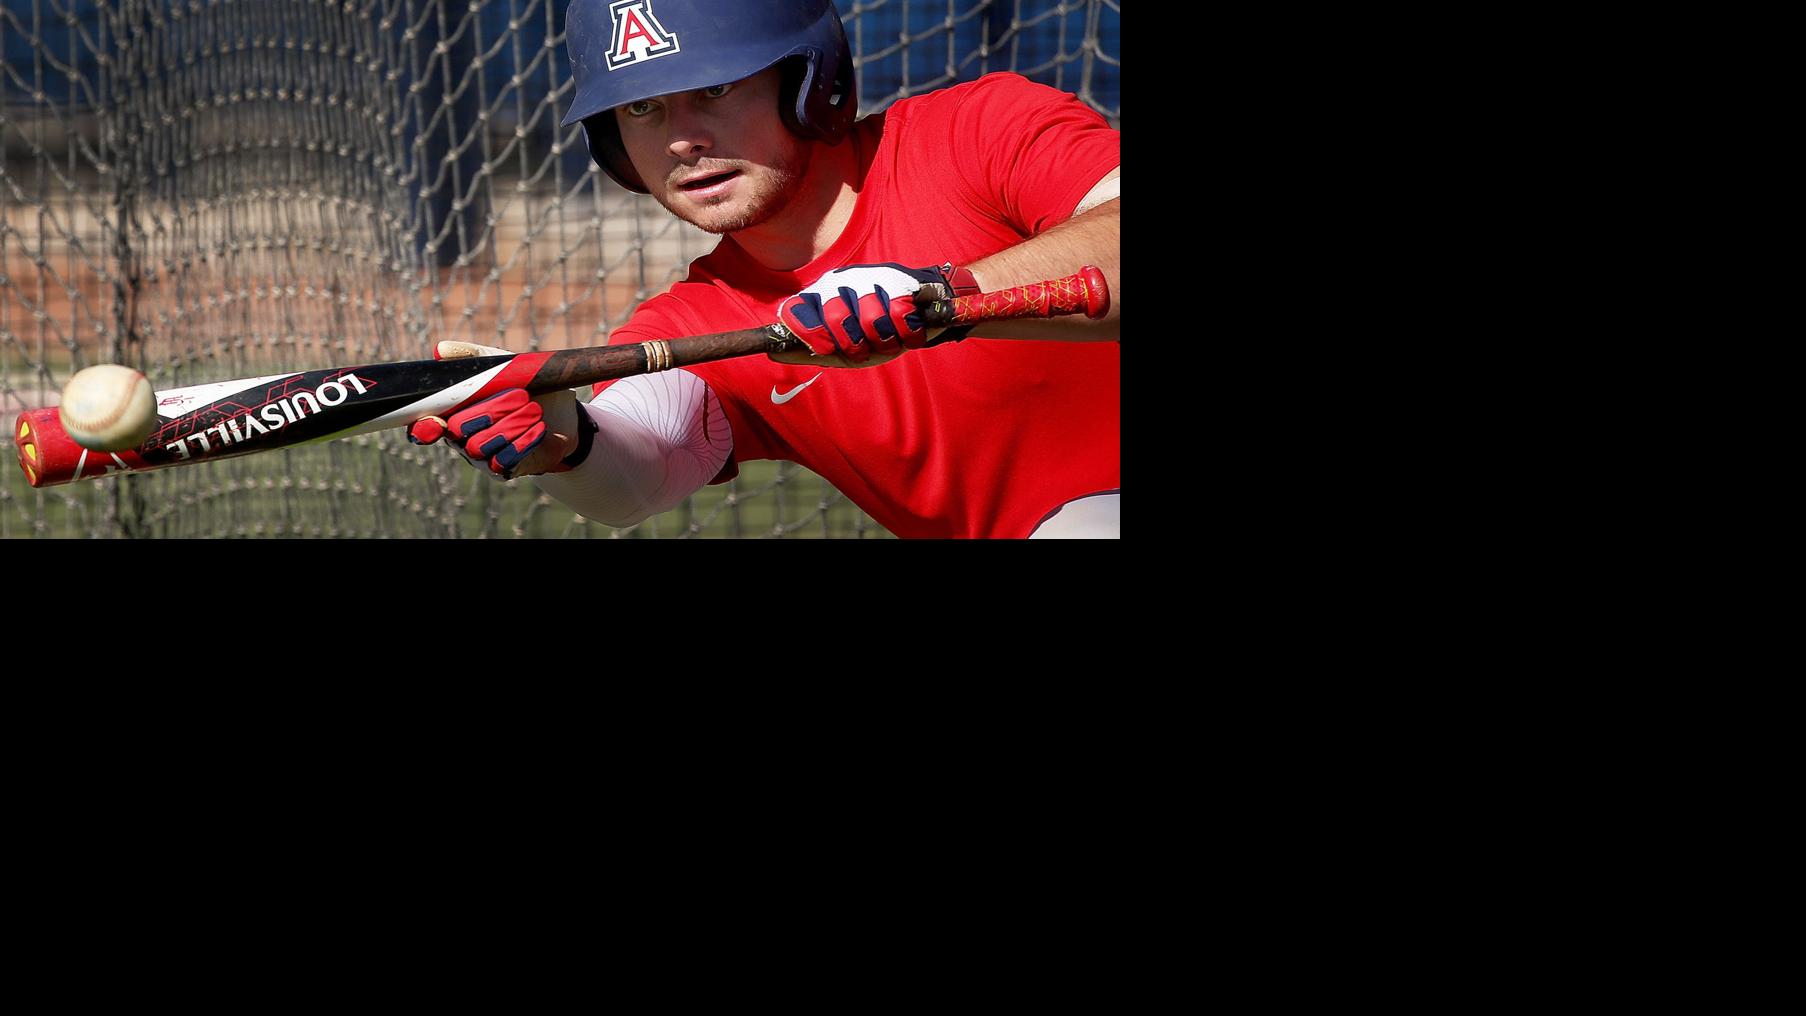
[598,72,1122,538]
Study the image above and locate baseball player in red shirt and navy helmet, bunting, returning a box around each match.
[410,0,1122,538]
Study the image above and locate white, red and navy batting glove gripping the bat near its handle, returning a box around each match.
[778,262,979,363]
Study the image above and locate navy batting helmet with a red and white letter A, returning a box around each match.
[560,0,858,193]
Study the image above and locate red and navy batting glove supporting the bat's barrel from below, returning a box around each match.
[408,343,596,480]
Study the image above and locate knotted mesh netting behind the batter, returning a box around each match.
[0,0,1122,538]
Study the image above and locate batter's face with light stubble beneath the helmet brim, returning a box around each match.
[614,67,811,233]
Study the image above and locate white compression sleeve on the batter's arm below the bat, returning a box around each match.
[533,370,733,527]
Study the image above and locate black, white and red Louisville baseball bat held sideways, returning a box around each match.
[13,265,1111,487]
